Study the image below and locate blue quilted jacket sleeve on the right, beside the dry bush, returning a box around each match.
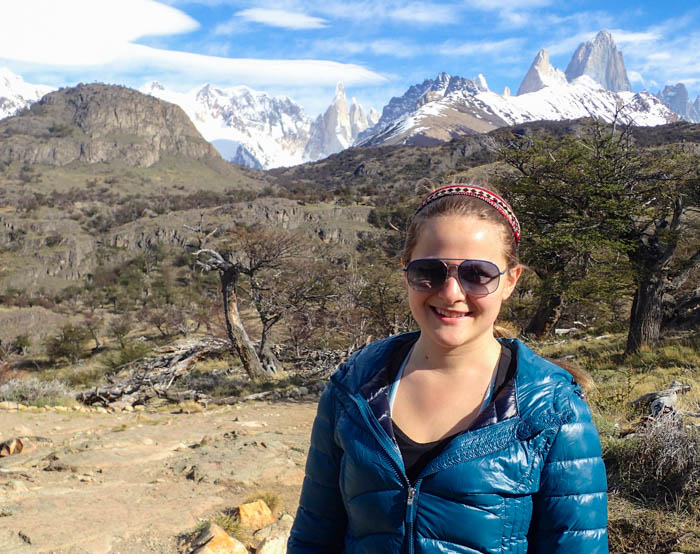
[528,386,608,554]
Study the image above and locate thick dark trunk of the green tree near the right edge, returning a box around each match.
[625,273,664,354]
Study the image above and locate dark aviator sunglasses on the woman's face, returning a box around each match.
[403,258,506,296]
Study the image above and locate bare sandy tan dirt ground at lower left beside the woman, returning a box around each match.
[0,401,316,553]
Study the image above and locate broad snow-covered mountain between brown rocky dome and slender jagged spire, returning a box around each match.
[140,82,311,169]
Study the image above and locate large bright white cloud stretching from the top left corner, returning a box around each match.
[0,0,386,86]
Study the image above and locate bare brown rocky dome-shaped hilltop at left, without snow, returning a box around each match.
[0,84,219,167]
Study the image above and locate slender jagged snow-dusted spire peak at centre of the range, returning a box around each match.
[304,83,379,161]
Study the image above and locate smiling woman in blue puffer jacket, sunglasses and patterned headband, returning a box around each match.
[288,184,608,554]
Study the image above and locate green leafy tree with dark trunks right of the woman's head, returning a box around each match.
[501,122,700,352]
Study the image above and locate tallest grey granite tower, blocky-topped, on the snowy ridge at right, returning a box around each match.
[566,31,632,92]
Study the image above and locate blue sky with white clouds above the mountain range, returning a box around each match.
[0,0,700,116]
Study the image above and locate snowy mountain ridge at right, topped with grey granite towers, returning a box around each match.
[360,31,680,145]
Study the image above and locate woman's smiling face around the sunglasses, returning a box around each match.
[406,215,521,350]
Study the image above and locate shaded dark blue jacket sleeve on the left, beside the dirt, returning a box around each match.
[287,384,347,554]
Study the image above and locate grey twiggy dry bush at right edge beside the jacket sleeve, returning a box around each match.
[603,414,700,511]
